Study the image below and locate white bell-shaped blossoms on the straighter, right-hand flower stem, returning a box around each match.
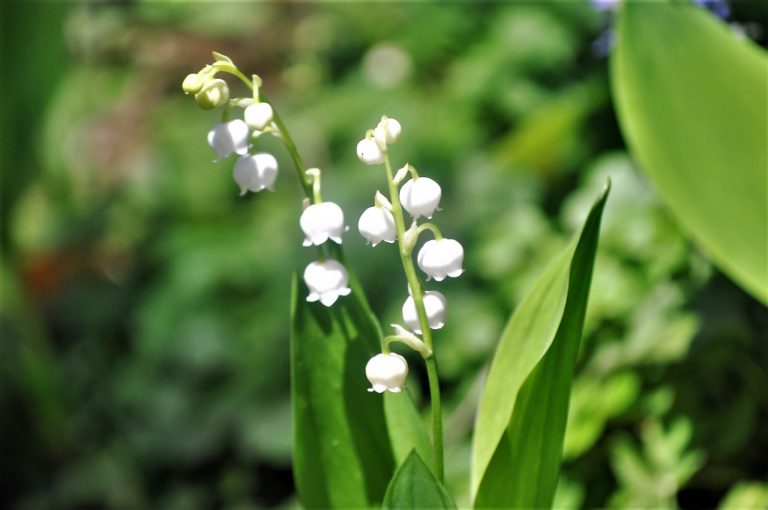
[357,116,464,393]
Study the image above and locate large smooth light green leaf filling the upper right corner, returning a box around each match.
[611,2,768,303]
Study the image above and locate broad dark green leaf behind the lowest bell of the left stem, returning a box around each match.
[291,276,395,508]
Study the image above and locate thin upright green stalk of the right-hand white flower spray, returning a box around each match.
[384,152,445,483]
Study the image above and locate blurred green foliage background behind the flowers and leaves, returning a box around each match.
[0,1,768,509]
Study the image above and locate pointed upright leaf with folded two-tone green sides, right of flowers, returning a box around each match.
[472,183,610,508]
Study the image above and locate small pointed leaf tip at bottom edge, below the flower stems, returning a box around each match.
[384,451,456,510]
